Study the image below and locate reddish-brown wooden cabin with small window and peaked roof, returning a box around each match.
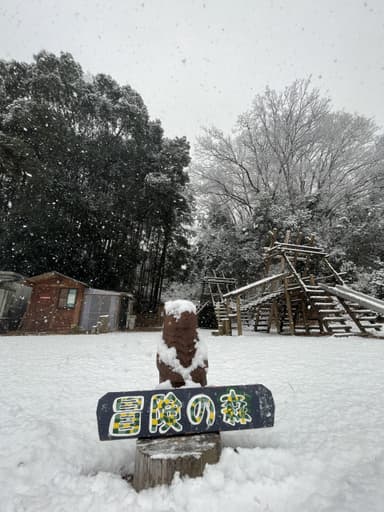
[22,272,88,333]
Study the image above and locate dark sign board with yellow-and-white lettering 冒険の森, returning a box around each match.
[97,384,275,441]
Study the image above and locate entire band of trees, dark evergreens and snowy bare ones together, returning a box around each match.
[0,56,384,310]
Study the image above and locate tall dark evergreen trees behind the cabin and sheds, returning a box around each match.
[0,52,191,309]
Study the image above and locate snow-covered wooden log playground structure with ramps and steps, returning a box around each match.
[198,232,384,336]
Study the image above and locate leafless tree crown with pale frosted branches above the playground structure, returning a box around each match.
[194,79,384,221]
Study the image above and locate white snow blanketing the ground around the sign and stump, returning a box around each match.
[0,331,384,512]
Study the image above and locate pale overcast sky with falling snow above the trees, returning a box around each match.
[0,0,384,143]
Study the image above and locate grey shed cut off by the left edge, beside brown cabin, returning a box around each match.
[0,271,31,332]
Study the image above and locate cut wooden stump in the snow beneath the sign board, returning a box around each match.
[133,433,221,491]
